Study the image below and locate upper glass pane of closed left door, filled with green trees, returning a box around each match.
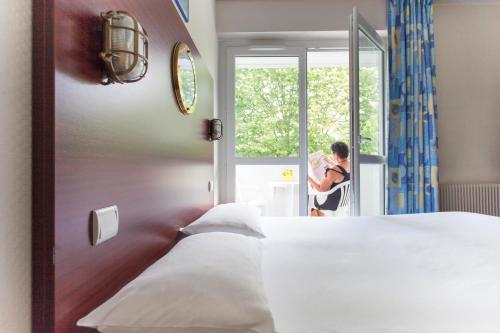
[235,57,299,157]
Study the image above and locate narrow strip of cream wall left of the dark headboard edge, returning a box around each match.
[0,0,31,333]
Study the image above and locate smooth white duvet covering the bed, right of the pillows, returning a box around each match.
[262,213,500,333]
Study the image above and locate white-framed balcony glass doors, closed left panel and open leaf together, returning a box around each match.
[225,10,387,216]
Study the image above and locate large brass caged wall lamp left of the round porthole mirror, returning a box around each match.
[99,10,149,84]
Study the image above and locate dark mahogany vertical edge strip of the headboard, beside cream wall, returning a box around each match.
[31,0,55,333]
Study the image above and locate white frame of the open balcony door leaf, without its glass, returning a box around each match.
[349,7,388,216]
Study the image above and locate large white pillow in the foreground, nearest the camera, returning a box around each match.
[78,232,274,333]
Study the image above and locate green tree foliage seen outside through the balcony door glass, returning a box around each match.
[235,67,380,157]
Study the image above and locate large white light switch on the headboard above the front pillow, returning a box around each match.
[92,206,119,245]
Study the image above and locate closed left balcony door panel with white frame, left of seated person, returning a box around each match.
[226,48,307,216]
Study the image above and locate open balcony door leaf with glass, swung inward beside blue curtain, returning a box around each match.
[349,8,387,215]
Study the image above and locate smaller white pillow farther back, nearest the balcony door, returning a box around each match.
[181,203,265,238]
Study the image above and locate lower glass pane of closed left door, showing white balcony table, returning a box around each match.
[236,165,299,216]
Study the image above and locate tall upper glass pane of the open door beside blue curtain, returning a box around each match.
[359,31,383,155]
